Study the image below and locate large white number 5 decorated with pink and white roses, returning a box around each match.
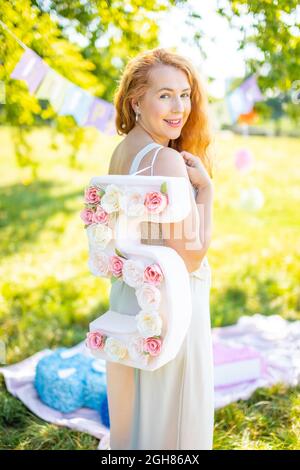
[81,175,192,370]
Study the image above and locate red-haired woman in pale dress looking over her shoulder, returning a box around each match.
[106,48,214,450]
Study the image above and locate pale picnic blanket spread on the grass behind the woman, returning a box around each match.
[0,314,300,449]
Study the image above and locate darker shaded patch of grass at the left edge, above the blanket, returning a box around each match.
[0,180,83,256]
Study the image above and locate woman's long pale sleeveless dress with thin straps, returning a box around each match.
[106,142,214,450]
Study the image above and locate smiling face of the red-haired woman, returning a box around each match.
[132,65,191,146]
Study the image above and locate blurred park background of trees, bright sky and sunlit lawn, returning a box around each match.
[0,0,300,449]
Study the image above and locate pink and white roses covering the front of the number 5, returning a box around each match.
[80,182,169,363]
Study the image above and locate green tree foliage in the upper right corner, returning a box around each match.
[218,0,300,122]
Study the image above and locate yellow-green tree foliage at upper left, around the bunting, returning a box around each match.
[0,0,186,177]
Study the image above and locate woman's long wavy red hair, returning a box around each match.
[114,47,213,178]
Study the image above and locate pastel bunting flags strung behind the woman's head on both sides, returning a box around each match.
[0,20,263,135]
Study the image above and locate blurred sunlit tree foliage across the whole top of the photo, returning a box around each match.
[0,0,300,179]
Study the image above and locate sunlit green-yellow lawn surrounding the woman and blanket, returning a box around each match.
[0,128,300,449]
